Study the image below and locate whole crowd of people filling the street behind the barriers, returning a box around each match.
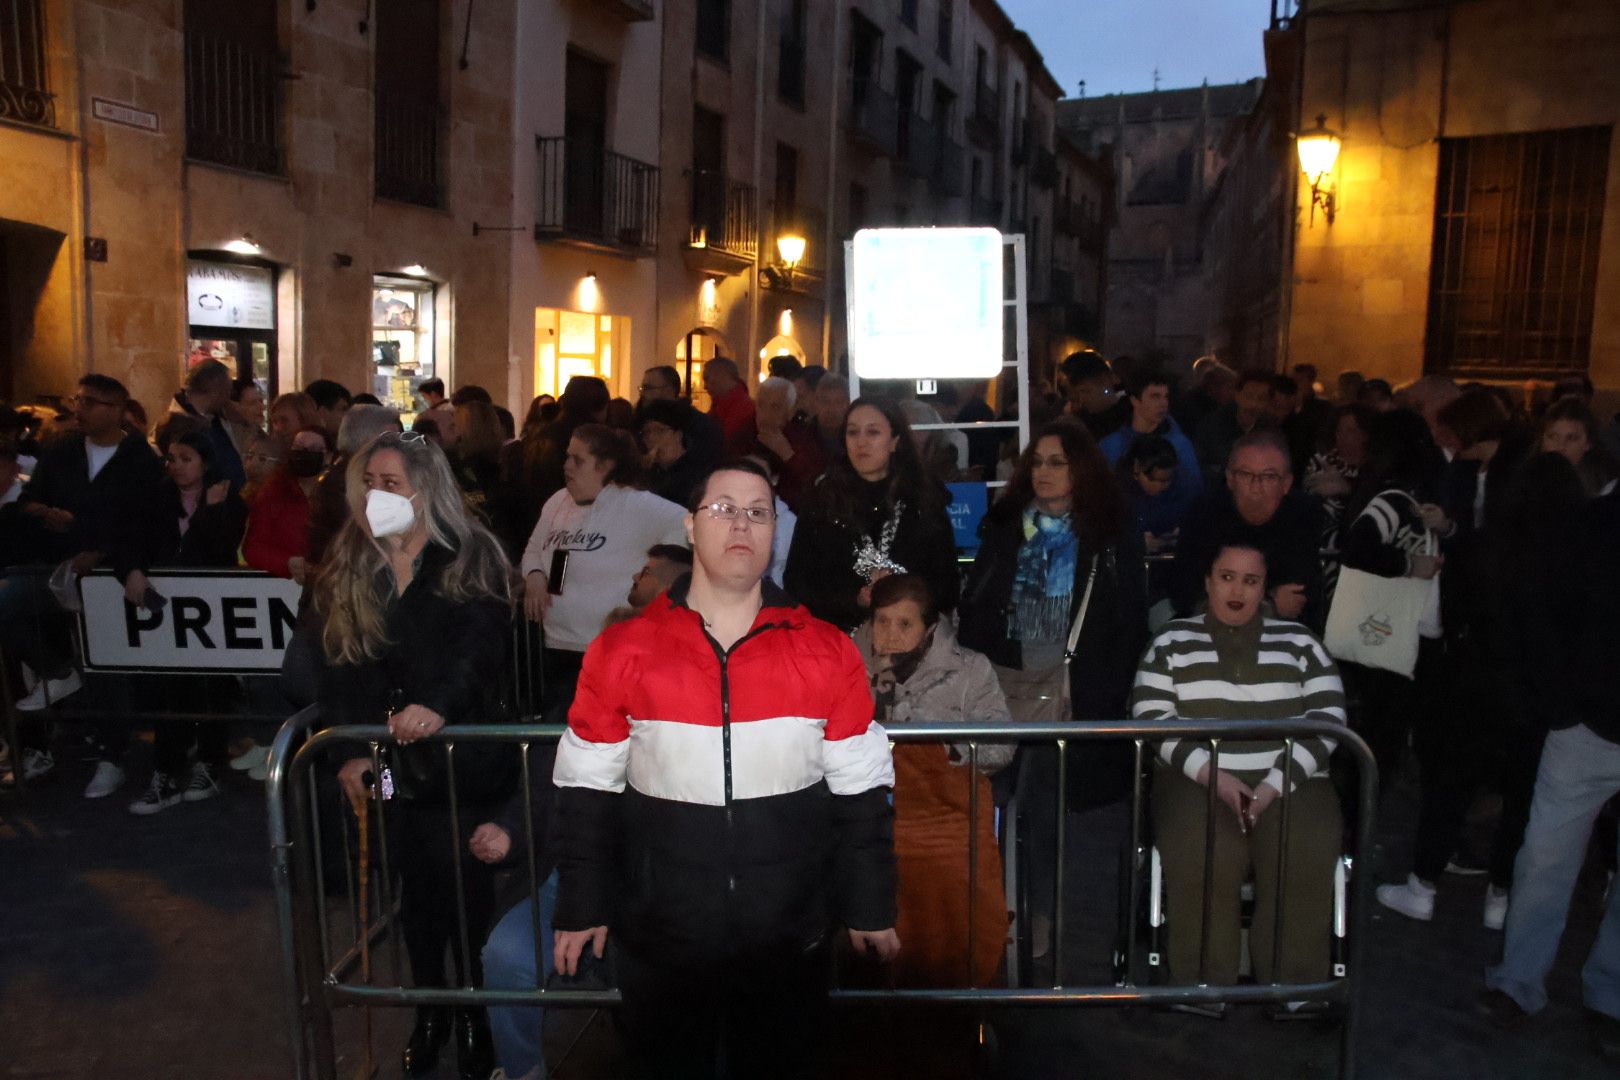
[0,351,1620,1080]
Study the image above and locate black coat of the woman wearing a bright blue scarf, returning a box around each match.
[957,504,1149,810]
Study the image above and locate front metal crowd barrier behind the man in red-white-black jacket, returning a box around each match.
[266,718,1379,1080]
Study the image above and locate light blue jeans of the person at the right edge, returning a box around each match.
[1486,724,1620,1018]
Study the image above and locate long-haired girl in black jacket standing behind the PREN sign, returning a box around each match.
[117,418,248,814]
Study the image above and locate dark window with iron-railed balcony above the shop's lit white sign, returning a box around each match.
[185,0,284,173]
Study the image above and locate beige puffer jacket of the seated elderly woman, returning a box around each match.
[855,619,1017,774]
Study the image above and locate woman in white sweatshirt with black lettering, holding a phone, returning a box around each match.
[522,424,687,712]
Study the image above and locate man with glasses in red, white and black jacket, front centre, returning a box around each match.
[552,461,899,1077]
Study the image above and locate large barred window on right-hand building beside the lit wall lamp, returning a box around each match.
[1424,128,1610,376]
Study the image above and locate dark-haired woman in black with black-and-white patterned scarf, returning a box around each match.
[782,398,961,630]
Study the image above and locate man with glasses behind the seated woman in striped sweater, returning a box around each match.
[1170,429,1327,628]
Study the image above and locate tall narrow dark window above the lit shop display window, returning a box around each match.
[376,0,444,207]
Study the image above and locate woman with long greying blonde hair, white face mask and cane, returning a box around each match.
[314,432,517,1077]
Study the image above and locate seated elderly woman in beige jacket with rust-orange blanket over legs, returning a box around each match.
[855,573,1013,986]
